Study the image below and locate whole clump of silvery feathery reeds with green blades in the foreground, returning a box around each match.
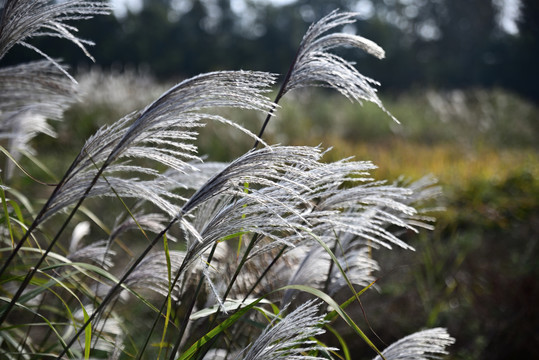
[0,0,454,359]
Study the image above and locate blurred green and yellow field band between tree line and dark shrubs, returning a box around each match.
[264,90,539,188]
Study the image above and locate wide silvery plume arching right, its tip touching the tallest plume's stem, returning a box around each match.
[42,71,274,219]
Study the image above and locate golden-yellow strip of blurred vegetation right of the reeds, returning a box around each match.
[306,135,539,187]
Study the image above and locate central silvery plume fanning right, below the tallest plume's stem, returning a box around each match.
[177,146,321,268]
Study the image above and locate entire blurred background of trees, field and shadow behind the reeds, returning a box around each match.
[0,0,539,359]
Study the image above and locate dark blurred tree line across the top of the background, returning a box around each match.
[3,0,539,101]
